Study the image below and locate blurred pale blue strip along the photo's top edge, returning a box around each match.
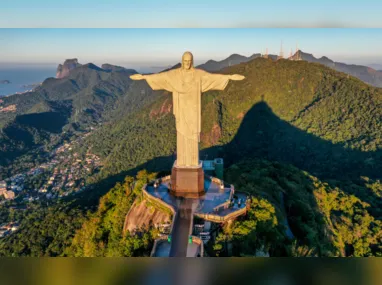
[0,0,382,28]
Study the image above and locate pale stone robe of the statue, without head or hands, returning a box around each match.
[145,68,229,167]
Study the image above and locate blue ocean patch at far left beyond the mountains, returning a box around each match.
[0,67,56,97]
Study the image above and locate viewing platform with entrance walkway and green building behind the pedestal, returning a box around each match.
[142,159,249,257]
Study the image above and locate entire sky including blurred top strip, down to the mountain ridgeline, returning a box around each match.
[0,0,382,68]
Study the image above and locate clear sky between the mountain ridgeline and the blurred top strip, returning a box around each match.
[0,28,382,68]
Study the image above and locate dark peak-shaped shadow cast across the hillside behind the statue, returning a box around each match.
[72,102,381,255]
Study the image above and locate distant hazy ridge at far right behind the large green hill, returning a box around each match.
[291,50,382,87]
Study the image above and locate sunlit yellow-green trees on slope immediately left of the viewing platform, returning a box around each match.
[66,171,158,257]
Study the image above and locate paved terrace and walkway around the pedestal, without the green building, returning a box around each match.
[144,175,247,257]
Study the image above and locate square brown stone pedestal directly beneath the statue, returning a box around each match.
[170,161,205,198]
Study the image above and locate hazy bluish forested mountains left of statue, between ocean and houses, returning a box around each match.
[0,60,155,164]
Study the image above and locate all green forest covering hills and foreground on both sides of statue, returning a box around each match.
[0,58,382,256]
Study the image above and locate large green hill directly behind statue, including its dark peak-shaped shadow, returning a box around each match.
[89,58,382,181]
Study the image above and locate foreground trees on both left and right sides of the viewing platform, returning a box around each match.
[0,160,382,256]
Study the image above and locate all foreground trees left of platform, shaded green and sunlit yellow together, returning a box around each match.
[0,171,158,257]
